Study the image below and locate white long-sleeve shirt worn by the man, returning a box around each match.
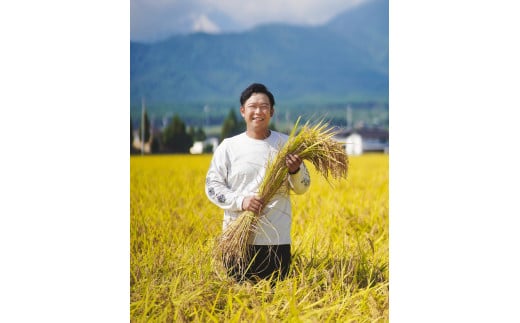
[206,131,310,245]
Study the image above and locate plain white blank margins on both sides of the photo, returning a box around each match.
[0,1,520,322]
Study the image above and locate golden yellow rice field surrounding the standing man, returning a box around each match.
[130,154,389,322]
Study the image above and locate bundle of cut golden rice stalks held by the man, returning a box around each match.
[215,118,349,273]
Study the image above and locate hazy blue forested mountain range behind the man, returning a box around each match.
[130,0,389,126]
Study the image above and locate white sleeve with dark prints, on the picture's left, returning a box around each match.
[205,144,244,212]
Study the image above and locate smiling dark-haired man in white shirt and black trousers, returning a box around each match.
[206,83,310,281]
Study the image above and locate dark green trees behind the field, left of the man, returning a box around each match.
[130,109,250,154]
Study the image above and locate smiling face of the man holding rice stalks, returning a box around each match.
[240,93,274,129]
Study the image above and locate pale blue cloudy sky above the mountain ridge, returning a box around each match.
[130,0,369,41]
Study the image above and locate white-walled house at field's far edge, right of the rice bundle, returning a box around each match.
[334,128,389,156]
